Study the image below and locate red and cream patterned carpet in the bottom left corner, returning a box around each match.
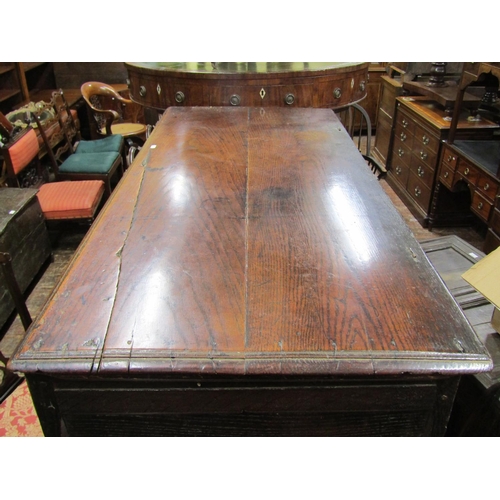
[0,382,43,437]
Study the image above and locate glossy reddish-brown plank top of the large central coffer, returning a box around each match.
[11,107,492,376]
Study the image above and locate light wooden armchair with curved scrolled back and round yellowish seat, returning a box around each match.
[81,82,147,145]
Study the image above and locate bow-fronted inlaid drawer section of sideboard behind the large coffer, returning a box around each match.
[125,62,369,111]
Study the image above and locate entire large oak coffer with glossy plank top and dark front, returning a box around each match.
[10,107,492,436]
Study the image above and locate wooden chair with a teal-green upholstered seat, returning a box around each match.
[33,98,123,197]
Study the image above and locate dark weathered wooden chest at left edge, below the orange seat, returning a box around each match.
[0,188,51,326]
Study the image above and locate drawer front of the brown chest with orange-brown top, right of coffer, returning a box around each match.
[390,103,441,225]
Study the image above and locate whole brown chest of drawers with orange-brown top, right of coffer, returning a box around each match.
[387,96,498,227]
